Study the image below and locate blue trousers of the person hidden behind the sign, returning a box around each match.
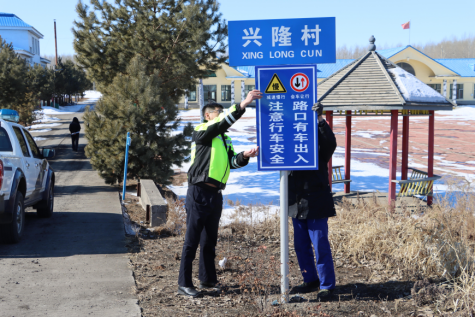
[292,218,336,289]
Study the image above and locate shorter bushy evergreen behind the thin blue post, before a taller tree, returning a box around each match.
[84,57,193,184]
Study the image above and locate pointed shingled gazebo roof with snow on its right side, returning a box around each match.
[317,42,454,111]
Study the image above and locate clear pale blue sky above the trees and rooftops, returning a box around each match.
[0,0,475,55]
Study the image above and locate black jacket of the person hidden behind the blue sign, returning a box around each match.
[289,120,336,219]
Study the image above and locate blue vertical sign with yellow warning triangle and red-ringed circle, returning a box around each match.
[256,65,318,171]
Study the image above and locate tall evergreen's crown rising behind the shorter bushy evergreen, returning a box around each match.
[73,0,227,103]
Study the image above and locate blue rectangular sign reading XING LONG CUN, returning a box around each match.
[228,18,336,66]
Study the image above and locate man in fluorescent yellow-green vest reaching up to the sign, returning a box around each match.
[178,90,262,297]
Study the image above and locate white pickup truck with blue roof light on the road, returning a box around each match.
[0,109,55,243]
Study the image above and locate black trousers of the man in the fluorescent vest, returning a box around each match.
[178,184,223,287]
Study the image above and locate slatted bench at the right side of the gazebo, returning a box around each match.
[393,167,442,197]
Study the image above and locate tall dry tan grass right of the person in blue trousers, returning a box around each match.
[329,180,475,313]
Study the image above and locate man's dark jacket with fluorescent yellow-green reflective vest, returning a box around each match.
[188,104,249,189]
